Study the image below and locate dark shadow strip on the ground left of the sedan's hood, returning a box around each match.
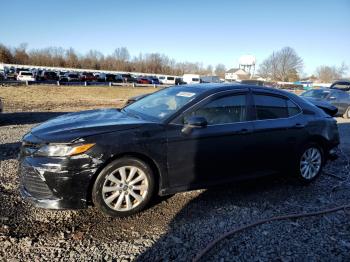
[0,112,69,126]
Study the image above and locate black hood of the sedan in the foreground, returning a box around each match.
[28,109,150,143]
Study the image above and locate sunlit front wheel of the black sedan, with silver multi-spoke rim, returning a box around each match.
[92,157,155,217]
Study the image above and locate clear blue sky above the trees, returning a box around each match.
[0,0,350,74]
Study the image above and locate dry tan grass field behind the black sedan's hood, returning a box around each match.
[0,85,157,112]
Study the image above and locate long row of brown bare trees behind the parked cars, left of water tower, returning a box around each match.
[0,44,226,77]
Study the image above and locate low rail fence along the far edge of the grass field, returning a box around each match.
[0,80,169,88]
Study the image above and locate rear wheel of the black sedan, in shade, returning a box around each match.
[295,143,325,184]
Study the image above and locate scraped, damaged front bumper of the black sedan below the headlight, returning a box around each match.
[19,152,98,209]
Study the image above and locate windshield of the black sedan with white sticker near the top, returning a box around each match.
[124,86,203,121]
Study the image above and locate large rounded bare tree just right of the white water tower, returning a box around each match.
[258,47,303,81]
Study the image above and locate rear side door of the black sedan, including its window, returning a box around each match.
[251,91,306,174]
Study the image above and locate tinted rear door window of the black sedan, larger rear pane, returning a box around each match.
[254,95,288,120]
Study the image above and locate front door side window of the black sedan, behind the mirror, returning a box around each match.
[184,95,247,125]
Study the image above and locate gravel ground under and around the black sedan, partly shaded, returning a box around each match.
[0,112,350,261]
